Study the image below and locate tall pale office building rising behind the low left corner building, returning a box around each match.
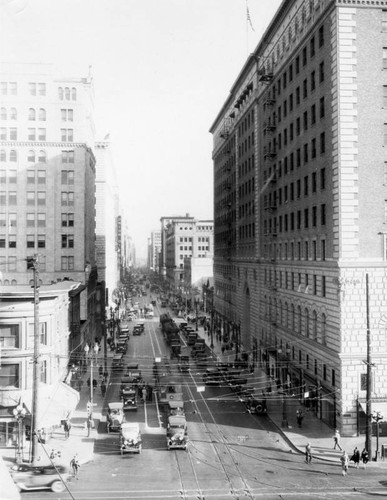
[0,63,95,285]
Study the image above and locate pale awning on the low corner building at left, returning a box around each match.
[24,382,79,429]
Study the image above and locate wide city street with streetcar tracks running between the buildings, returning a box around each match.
[19,298,385,500]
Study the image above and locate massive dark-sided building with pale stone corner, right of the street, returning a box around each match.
[211,0,387,434]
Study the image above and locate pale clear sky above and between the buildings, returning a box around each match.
[0,0,281,258]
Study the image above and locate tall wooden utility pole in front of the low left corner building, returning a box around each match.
[27,254,40,464]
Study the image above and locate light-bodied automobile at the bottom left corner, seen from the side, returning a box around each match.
[9,464,70,493]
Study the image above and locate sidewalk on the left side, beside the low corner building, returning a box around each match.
[0,345,113,467]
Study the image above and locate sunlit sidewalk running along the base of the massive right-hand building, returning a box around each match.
[194,326,387,468]
